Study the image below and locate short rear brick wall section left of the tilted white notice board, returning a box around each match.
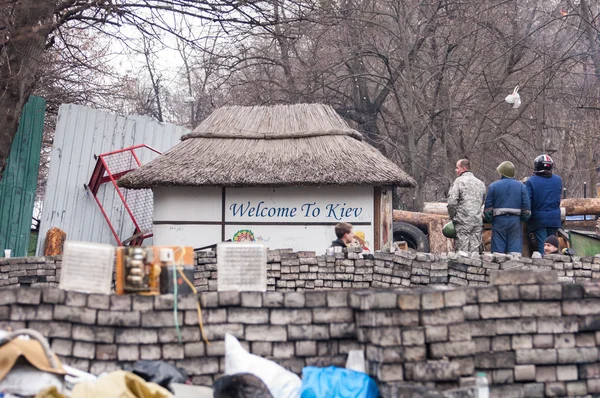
[0,257,61,288]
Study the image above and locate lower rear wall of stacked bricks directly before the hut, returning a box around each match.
[0,250,600,291]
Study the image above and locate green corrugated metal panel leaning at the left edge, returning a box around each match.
[0,96,46,257]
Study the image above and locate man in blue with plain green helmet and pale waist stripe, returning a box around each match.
[483,162,531,253]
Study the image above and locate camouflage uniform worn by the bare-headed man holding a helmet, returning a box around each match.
[448,171,485,252]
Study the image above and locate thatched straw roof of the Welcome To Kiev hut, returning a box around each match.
[119,104,415,189]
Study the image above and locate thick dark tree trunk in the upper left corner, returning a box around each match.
[0,0,54,179]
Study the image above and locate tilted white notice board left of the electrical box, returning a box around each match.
[59,242,115,294]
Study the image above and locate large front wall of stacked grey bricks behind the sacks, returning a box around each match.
[0,270,600,397]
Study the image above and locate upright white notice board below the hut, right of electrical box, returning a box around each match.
[217,242,267,292]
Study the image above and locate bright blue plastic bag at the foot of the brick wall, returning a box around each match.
[300,366,379,398]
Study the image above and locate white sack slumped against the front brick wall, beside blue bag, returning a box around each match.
[225,333,302,398]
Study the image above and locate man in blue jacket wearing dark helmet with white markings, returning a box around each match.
[525,155,562,253]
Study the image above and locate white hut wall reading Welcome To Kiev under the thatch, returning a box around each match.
[154,186,374,252]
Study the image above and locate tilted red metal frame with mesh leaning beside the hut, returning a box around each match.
[85,144,161,246]
